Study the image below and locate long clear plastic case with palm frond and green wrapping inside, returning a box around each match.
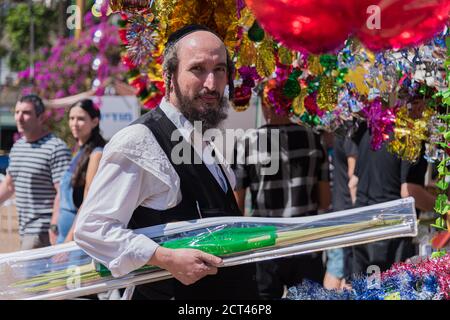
[0,198,417,299]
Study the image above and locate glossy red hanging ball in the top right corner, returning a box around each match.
[357,0,450,51]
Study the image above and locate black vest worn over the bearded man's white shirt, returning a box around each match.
[128,108,258,300]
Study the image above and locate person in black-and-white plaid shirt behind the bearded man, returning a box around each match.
[232,99,330,299]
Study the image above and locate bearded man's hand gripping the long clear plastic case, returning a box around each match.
[148,247,222,285]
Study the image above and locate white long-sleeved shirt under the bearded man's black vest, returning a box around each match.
[74,100,236,277]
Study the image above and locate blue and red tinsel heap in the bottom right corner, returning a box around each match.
[287,255,450,300]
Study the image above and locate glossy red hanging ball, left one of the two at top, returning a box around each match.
[246,0,354,54]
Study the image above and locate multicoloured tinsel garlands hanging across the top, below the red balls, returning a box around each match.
[111,0,448,158]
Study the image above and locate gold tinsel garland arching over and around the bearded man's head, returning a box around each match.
[110,0,294,111]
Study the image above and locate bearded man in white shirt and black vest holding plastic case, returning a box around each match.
[75,25,258,299]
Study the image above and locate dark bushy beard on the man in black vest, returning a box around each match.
[174,84,230,132]
